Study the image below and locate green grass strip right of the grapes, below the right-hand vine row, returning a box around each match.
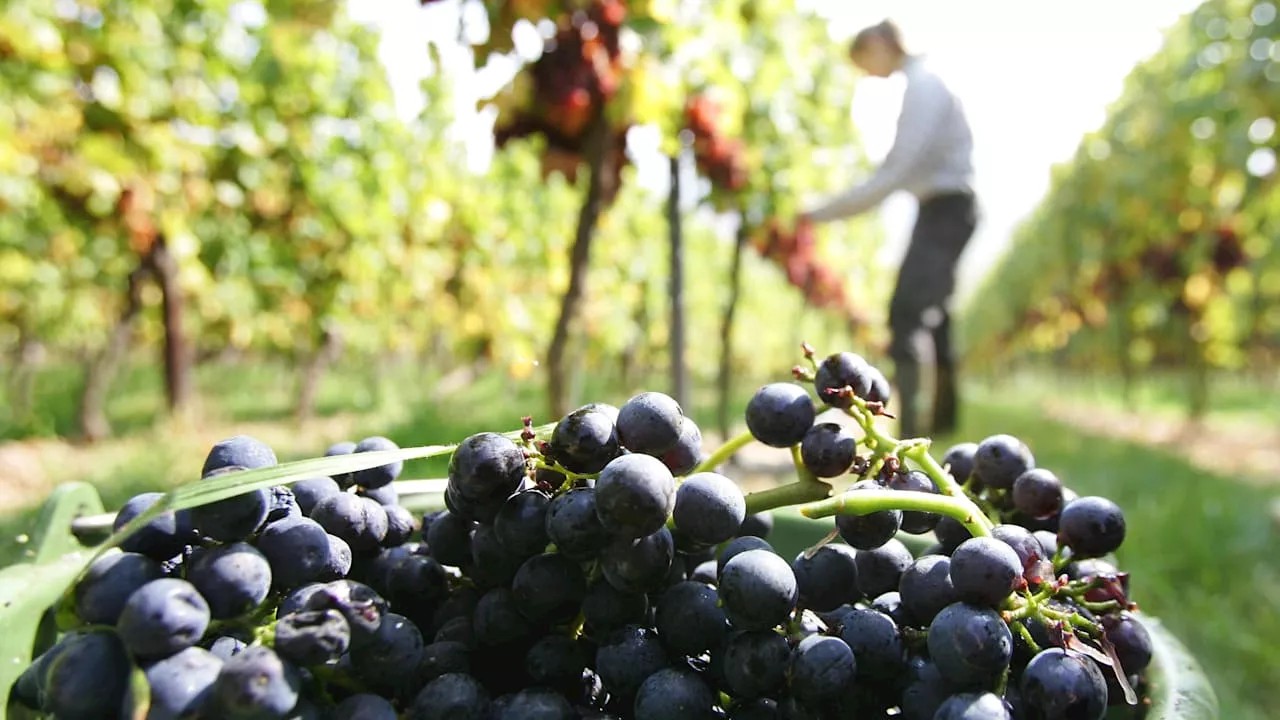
[938,389,1280,720]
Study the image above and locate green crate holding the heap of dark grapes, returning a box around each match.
[0,483,1219,720]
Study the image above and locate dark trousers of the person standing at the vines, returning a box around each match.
[888,193,977,437]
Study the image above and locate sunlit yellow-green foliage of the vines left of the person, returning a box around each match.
[0,0,882,430]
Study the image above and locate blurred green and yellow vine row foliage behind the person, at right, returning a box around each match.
[965,0,1280,374]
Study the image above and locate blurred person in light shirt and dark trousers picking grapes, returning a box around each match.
[797,20,977,437]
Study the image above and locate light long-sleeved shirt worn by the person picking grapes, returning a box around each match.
[809,56,973,223]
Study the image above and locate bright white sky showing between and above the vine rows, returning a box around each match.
[349,0,1199,296]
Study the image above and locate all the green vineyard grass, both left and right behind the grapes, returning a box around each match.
[0,365,1280,720]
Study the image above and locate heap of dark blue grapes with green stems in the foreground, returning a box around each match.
[13,347,1152,720]
